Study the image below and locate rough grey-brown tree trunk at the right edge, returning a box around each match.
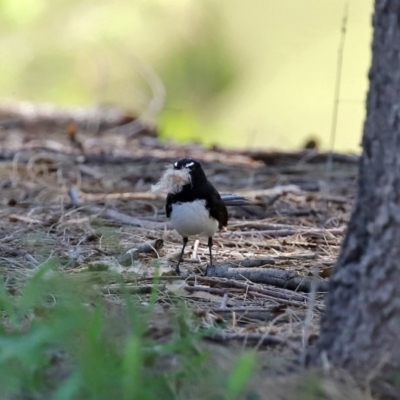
[317,0,400,399]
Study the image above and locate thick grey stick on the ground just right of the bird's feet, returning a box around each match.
[206,265,328,292]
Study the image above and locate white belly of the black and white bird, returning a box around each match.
[171,200,218,237]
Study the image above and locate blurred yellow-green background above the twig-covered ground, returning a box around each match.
[0,0,373,151]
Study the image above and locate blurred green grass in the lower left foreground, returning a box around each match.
[0,260,254,400]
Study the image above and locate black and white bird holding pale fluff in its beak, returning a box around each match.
[153,158,248,274]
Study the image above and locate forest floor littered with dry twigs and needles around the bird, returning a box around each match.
[0,106,364,399]
